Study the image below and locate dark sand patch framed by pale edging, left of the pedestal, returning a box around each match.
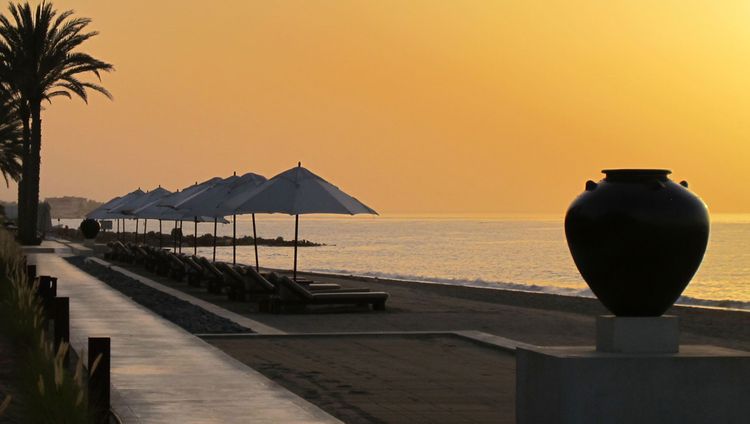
[208,335,516,423]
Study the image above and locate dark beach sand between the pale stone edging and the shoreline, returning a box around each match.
[113,265,750,350]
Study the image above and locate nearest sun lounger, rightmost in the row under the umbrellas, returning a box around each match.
[270,277,388,313]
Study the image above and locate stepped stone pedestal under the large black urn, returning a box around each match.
[516,317,750,423]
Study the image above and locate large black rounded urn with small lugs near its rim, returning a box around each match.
[565,169,709,316]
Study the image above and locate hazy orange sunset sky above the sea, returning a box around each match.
[0,0,750,213]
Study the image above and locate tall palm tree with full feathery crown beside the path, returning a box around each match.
[0,2,114,244]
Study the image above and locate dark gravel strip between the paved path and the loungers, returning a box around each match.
[65,256,252,334]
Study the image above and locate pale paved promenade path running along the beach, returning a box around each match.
[28,241,339,423]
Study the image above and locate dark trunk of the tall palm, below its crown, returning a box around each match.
[20,101,42,244]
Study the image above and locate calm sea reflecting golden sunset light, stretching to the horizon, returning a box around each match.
[62,215,750,310]
